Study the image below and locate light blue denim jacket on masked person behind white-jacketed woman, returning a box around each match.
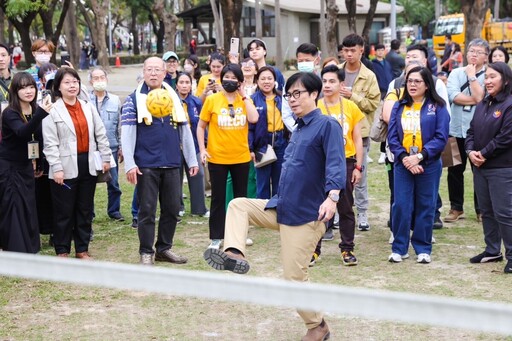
[90,91,121,153]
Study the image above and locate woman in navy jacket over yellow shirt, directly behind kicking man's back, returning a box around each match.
[249,66,289,199]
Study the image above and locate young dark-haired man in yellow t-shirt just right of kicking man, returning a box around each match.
[311,65,365,266]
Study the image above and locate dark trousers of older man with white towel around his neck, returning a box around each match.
[137,168,181,253]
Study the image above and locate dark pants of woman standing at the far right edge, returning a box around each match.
[473,167,512,260]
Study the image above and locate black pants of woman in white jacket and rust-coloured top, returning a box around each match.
[51,153,96,254]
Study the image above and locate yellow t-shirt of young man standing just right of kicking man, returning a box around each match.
[317,98,364,158]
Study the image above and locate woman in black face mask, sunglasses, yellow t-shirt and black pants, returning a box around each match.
[197,64,258,249]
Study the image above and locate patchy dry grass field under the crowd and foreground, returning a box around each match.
[0,145,512,340]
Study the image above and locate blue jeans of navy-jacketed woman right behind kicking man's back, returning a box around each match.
[256,131,288,199]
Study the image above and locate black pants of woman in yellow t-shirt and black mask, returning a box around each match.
[208,162,249,239]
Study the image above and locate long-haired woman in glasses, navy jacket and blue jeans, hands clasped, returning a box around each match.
[388,66,450,264]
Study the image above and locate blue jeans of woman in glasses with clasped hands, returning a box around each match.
[391,160,442,255]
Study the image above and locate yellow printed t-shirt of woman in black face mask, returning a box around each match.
[200,92,251,165]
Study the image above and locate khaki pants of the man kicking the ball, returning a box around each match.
[224,198,325,329]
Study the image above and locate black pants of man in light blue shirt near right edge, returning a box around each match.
[448,137,480,214]
